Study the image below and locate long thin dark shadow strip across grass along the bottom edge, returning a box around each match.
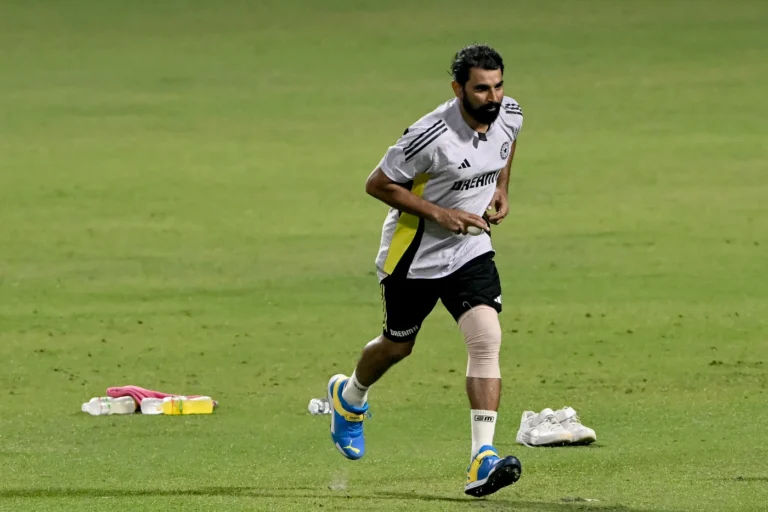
[0,486,658,512]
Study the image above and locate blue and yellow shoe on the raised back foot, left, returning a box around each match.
[328,374,368,460]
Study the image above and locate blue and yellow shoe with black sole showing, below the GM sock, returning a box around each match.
[464,445,523,498]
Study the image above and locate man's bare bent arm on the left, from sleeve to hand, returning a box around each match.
[365,167,488,234]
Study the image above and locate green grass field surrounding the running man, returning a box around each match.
[0,0,768,512]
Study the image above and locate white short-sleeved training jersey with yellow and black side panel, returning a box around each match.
[376,96,523,279]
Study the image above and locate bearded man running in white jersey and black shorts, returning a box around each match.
[328,45,523,496]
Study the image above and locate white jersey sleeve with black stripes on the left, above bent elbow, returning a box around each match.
[379,119,448,183]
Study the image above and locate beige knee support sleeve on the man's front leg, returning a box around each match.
[459,306,501,379]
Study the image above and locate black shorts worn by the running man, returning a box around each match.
[381,252,501,341]
